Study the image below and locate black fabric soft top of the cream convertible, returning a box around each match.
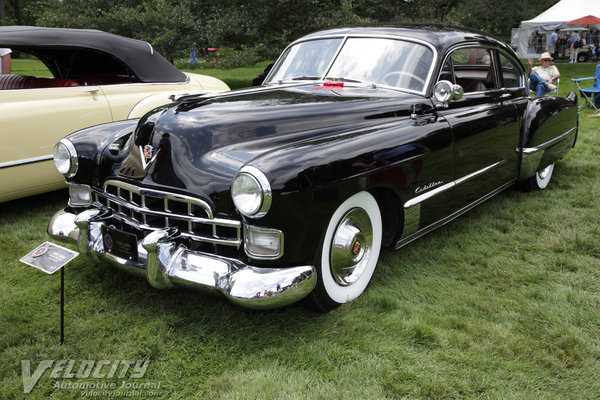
[0,26,188,83]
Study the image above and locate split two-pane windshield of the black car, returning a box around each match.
[269,37,433,92]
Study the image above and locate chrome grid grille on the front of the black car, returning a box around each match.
[94,180,242,248]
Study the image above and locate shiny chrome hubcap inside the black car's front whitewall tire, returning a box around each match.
[330,208,373,286]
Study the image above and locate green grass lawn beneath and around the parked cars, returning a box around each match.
[0,64,600,400]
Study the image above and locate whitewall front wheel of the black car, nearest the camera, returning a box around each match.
[308,192,382,312]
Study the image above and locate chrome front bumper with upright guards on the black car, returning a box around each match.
[48,209,317,309]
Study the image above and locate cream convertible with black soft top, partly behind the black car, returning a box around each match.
[0,26,229,202]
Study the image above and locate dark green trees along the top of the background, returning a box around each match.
[0,0,558,60]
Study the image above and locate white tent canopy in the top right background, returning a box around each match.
[511,0,600,58]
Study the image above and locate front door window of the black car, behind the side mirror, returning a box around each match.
[442,47,498,93]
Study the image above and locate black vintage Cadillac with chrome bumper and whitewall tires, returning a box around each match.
[48,27,578,310]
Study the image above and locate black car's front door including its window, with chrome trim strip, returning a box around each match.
[440,45,523,210]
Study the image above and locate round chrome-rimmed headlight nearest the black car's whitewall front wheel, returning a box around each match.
[231,166,271,218]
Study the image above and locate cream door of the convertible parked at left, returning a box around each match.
[0,86,112,202]
